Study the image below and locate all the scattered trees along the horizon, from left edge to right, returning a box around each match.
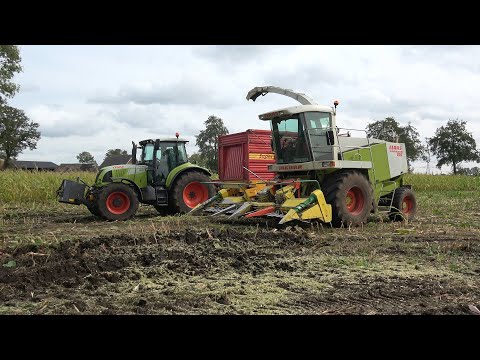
[0,45,480,175]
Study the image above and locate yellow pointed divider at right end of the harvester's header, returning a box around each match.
[279,190,332,224]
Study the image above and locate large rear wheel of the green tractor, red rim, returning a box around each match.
[169,171,217,213]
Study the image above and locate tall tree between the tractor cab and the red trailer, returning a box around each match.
[195,115,228,172]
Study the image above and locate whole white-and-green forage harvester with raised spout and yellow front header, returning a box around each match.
[190,86,416,226]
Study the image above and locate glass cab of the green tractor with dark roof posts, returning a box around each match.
[132,138,188,185]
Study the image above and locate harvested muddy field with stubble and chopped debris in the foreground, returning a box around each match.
[0,204,480,314]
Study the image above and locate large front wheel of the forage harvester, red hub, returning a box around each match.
[322,171,373,227]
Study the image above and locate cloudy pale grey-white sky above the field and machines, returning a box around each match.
[10,45,480,172]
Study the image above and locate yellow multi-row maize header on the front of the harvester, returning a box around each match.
[189,180,332,224]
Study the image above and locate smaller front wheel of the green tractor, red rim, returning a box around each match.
[96,183,138,221]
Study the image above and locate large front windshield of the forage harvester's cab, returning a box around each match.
[272,114,311,164]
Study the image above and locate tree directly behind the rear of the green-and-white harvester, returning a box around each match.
[367,117,425,171]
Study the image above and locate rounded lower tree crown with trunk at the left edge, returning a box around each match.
[0,104,40,168]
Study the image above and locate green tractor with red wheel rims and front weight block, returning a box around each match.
[57,133,216,221]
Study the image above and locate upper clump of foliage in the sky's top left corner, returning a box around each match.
[0,45,22,104]
